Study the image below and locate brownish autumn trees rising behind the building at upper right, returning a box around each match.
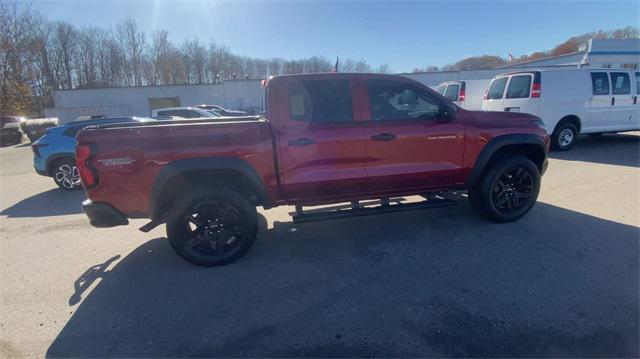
[412,26,640,73]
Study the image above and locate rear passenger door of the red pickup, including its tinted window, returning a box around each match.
[276,78,366,202]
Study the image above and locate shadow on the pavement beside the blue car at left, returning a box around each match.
[0,188,86,217]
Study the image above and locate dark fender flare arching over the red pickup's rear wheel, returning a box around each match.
[149,157,273,219]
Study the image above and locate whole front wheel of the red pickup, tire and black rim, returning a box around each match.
[469,156,540,222]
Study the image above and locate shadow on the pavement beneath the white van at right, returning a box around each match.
[549,134,640,167]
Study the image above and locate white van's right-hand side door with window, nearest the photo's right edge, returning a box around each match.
[607,72,639,131]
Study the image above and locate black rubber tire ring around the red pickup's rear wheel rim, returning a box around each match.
[166,188,258,267]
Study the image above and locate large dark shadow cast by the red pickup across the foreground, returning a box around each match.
[47,203,640,357]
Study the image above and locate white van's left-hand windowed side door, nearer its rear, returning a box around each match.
[585,72,611,131]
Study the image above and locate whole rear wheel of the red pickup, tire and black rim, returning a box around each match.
[167,188,258,267]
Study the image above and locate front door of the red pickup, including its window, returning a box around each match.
[365,79,464,191]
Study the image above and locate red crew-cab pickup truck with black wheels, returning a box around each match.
[76,73,549,266]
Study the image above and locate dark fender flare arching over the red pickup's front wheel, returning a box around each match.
[466,133,547,188]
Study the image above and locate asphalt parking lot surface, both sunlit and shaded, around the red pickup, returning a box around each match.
[0,133,640,357]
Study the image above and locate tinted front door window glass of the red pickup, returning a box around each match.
[367,80,440,121]
